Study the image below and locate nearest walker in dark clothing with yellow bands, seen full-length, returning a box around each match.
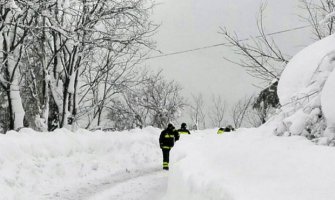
[159,124,179,170]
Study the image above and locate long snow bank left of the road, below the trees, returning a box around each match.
[0,128,161,200]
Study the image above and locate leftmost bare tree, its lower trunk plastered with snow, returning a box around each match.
[0,0,35,129]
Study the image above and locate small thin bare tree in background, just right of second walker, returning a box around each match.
[189,94,206,130]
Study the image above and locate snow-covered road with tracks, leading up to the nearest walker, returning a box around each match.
[45,167,168,200]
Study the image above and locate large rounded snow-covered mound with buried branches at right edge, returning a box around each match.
[270,35,335,144]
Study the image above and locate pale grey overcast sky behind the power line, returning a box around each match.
[145,0,318,126]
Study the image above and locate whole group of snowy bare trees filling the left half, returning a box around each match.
[0,0,183,131]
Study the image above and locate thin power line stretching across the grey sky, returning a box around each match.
[144,25,311,60]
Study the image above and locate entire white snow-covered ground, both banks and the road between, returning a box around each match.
[0,124,335,200]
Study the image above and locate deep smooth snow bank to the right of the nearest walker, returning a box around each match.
[164,128,335,200]
